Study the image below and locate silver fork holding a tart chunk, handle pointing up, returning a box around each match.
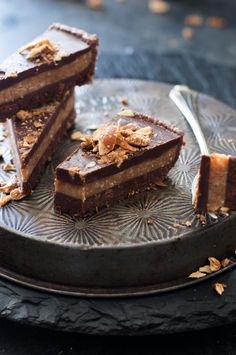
[169,85,218,219]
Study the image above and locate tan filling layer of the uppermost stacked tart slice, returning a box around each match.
[0,51,92,105]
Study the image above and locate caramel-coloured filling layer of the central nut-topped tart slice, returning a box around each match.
[55,147,179,201]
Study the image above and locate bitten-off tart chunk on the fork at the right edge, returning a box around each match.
[193,153,236,212]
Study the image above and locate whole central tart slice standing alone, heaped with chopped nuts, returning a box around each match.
[55,110,183,216]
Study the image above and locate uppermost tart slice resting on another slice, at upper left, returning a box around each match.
[0,23,98,120]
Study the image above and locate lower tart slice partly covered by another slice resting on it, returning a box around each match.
[4,90,76,195]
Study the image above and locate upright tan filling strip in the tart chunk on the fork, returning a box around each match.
[207,154,229,211]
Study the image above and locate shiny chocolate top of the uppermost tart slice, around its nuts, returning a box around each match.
[0,23,98,90]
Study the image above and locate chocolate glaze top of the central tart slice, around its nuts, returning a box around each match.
[56,113,183,183]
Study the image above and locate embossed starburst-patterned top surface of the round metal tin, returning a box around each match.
[0,79,236,248]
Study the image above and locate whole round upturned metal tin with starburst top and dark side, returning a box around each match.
[0,79,236,297]
